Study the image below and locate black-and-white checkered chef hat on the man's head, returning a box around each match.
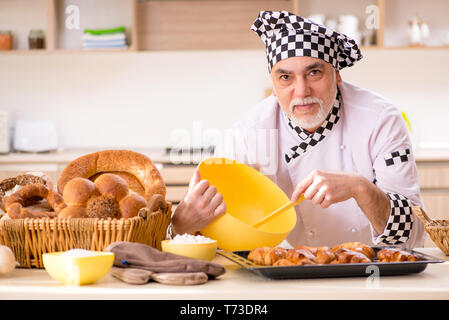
[251,11,362,71]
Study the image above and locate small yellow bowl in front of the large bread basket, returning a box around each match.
[42,251,114,286]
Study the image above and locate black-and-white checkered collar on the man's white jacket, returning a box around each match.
[285,90,342,163]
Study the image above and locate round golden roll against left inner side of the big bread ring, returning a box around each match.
[62,177,95,206]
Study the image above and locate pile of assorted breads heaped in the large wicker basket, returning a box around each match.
[0,150,166,219]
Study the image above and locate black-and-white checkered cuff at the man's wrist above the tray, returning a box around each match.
[376,192,413,245]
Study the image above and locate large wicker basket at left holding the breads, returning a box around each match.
[0,199,171,268]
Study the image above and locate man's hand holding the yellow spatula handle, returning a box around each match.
[291,170,361,208]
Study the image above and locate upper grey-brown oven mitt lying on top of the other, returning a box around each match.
[105,241,226,278]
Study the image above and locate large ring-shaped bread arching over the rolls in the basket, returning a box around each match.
[58,150,166,201]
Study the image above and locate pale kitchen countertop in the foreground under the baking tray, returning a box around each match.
[0,248,449,300]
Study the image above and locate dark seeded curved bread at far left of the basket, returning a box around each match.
[0,172,53,212]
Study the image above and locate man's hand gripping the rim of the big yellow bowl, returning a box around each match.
[172,170,226,234]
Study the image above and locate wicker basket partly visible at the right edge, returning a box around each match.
[412,207,449,256]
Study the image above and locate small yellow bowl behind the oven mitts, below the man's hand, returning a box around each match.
[161,240,217,261]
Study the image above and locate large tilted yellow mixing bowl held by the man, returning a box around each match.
[198,158,296,251]
